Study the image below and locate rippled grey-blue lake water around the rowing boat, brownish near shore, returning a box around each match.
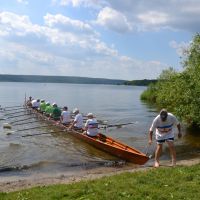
[0,83,200,177]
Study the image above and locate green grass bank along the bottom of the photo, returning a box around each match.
[0,164,200,200]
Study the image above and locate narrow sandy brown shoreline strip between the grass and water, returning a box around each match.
[0,154,200,192]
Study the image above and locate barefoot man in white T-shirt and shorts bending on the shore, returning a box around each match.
[149,109,182,167]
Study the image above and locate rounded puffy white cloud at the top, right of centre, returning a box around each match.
[96,7,132,33]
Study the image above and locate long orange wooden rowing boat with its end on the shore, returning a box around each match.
[28,104,149,165]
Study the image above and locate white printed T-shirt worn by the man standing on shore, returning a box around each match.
[150,113,179,140]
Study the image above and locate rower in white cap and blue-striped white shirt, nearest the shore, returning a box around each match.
[84,113,98,137]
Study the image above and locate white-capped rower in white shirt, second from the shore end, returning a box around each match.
[69,108,83,131]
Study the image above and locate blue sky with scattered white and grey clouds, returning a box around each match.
[0,0,200,80]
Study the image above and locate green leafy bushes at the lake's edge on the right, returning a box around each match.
[141,33,200,128]
